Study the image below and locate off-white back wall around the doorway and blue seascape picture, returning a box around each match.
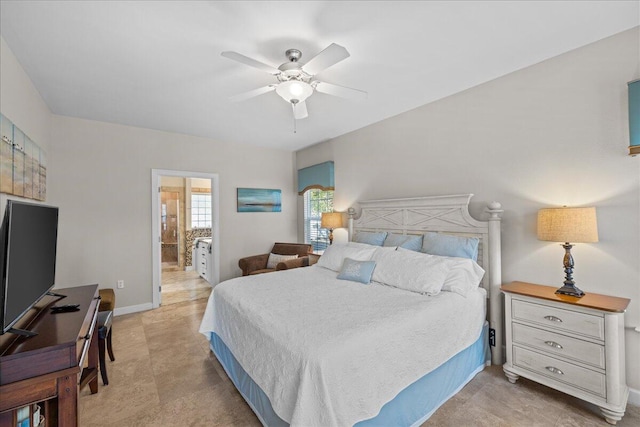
[49,116,296,307]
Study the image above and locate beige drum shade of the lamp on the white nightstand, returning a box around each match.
[538,207,598,243]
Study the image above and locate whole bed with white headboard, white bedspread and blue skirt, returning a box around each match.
[200,194,502,426]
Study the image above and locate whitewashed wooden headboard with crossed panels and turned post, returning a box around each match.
[348,194,504,365]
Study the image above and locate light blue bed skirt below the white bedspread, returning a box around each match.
[210,322,491,427]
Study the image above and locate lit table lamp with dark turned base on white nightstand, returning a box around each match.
[538,207,598,298]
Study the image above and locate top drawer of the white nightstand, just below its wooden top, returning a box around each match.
[511,299,604,340]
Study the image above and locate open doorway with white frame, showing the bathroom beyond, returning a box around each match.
[151,169,220,308]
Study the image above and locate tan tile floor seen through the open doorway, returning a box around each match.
[162,268,211,306]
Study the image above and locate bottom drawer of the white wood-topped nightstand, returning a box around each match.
[513,346,607,397]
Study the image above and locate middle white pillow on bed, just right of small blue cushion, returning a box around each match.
[371,248,452,295]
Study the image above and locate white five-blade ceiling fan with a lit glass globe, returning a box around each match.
[222,43,367,121]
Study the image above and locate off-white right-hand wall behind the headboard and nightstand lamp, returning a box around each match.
[297,28,640,394]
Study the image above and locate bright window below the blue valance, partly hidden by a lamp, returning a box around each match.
[304,190,333,252]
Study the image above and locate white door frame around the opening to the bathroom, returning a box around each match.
[151,169,220,308]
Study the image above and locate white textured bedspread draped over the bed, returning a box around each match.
[200,266,486,426]
